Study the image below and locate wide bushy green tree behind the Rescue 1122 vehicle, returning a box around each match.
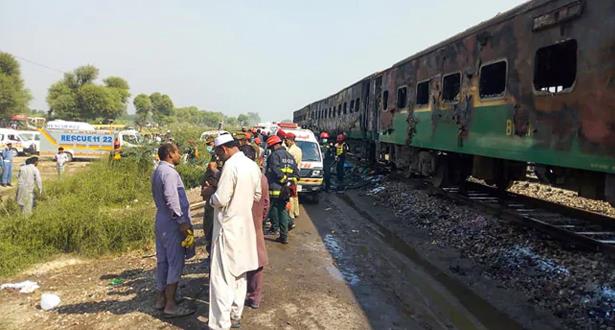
[47,65,130,120]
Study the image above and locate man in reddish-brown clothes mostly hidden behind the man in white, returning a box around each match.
[240,146,269,309]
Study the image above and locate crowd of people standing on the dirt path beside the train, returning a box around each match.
[152,125,348,329]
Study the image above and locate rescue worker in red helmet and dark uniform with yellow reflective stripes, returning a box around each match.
[265,135,299,244]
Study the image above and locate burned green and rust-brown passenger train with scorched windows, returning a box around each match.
[295,0,615,203]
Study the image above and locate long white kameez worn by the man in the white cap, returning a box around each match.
[210,152,262,277]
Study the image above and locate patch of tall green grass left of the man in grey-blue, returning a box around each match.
[0,153,154,276]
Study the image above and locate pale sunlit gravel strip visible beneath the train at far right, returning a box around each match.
[508,181,615,221]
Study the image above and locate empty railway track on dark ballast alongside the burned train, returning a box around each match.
[439,182,615,257]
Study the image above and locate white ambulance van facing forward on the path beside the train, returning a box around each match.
[278,123,324,203]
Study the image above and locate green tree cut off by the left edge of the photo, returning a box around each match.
[0,52,32,116]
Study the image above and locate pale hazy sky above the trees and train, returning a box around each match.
[0,0,525,121]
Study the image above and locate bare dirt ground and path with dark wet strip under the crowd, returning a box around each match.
[0,189,564,329]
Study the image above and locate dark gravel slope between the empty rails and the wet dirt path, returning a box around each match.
[367,177,615,330]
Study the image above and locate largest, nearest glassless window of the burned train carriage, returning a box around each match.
[534,39,577,94]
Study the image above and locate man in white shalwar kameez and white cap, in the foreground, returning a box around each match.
[208,134,261,329]
